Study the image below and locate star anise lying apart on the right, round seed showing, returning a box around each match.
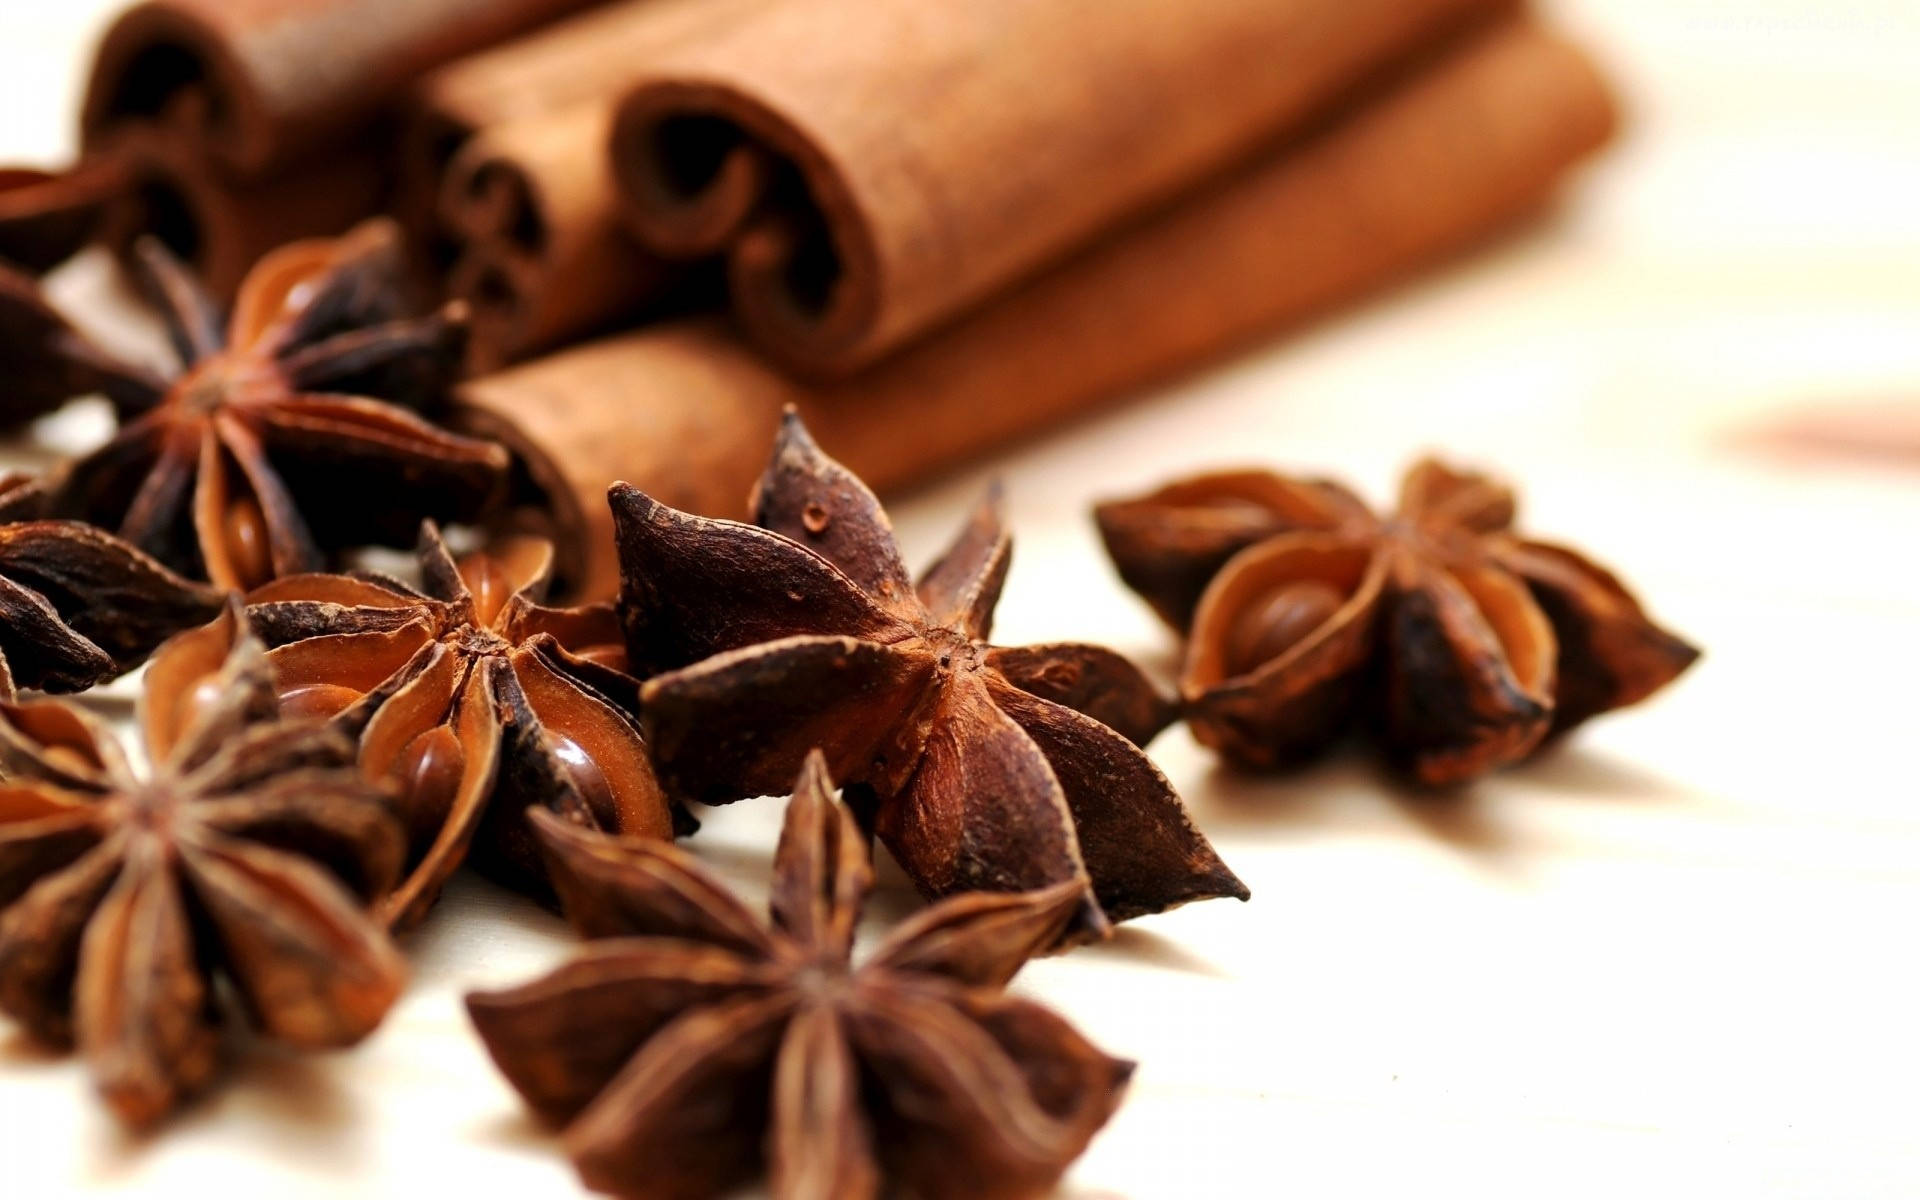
[1096,459,1699,785]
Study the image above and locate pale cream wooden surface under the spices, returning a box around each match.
[0,0,1920,1198]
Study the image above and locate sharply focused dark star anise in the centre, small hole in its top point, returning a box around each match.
[611,413,1248,939]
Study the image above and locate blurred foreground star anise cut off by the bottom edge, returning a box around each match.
[467,753,1133,1200]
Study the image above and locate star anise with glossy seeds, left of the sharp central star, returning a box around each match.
[248,522,676,925]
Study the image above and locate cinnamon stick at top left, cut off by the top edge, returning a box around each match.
[81,0,595,177]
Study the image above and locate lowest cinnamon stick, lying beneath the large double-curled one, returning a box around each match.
[463,21,1615,595]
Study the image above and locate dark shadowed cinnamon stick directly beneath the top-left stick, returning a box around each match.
[98,127,386,300]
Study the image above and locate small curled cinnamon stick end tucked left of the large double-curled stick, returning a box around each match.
[440,102,678,371]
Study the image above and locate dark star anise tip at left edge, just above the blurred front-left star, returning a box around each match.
[0,468,221,699]
